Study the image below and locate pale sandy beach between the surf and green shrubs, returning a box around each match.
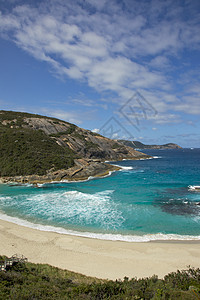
[0,220,200,279]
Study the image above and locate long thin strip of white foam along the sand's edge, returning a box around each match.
[0,213,200,242]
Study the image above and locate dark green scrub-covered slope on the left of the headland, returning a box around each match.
[0,112,75,176]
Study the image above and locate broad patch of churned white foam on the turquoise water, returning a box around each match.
[0,190,124,230]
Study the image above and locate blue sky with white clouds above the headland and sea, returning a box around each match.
[0,0,200,148]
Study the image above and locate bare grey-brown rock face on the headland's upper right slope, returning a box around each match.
[24,117,149,161]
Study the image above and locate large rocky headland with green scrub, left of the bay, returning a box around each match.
[0,111,148,182]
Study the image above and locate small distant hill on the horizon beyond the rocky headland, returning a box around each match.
[119,140,181,149]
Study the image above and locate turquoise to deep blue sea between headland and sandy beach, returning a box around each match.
[0,149,200,241]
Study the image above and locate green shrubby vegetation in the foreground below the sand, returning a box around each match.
[0,256,200,300]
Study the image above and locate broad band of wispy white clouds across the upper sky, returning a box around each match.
[0,0,200,123]
